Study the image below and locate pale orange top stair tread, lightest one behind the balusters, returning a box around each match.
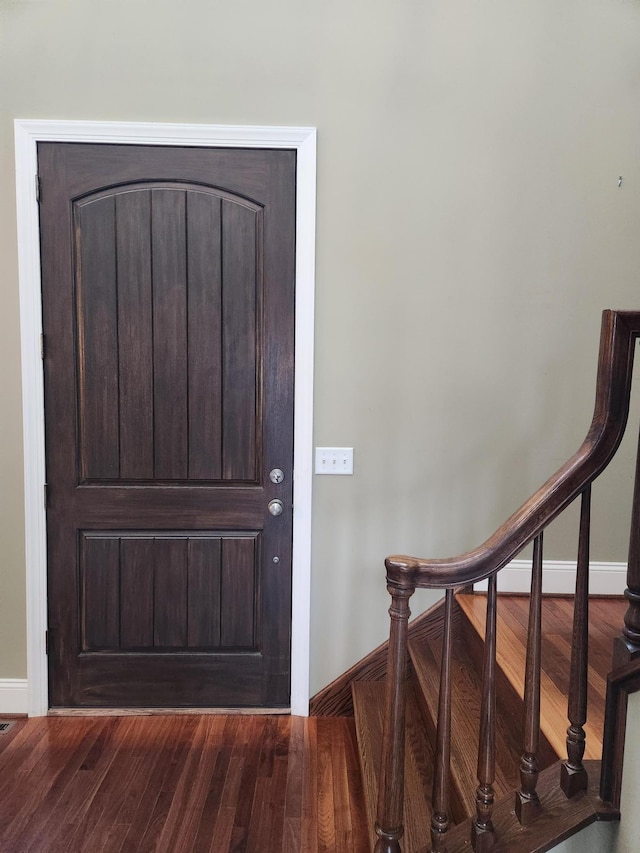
[456,594,602,760]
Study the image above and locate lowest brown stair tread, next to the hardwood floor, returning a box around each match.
[352,681,434,853]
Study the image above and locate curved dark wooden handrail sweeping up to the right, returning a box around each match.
[385,310,640,589]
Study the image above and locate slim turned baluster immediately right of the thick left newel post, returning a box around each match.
[431,589,453,853]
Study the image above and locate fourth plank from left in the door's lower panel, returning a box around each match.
[187,537,221,648]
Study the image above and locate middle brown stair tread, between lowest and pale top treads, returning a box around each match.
[409,641,521,820]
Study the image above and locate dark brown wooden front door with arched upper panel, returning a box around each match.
[38,143,296,708]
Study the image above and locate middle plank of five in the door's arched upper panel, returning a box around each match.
[151,189,189,480]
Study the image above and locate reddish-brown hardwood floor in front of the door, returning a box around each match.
[0,715,368,853]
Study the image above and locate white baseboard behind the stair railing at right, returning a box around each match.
[474,560,627,595]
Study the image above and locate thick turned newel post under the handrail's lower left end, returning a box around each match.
[375,585,414,853]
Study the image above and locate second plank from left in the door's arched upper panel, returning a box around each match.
[116,190,153,480]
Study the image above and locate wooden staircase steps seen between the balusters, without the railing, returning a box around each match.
[352,594,625,853]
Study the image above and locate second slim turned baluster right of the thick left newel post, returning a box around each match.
[471,575,497,853]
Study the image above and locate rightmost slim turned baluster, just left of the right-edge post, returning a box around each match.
[560,485,591,797]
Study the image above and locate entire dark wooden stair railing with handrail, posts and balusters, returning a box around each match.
[375,311,640,853]
